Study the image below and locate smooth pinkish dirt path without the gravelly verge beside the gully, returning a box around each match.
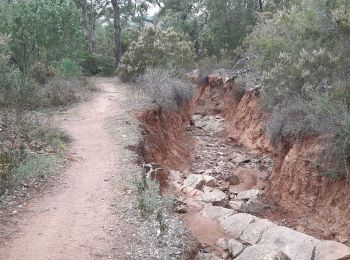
[0,80,131,260]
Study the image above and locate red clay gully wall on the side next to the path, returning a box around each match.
[137,104,193,187]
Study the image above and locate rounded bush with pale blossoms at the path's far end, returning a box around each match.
[119,27,194,80]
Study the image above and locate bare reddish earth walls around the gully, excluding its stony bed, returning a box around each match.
[140,76,350,244]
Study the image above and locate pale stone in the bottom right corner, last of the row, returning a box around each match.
[315,241,350,260]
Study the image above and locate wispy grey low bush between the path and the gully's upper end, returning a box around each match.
[135,68,194,110]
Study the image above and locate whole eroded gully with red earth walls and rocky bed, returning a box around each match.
[139,76,350,259]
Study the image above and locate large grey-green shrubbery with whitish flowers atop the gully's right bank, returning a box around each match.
[245,0,350,175]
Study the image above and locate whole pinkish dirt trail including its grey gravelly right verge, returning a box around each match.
[0,79,191,260]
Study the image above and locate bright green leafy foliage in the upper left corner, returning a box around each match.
[0,0,83,73]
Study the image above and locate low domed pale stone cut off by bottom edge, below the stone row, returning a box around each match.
[235,245,292,260]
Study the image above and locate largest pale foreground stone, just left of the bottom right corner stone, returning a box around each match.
[258,226,319,260]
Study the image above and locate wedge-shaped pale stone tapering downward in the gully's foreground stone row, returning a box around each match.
[219,213,256,239]
